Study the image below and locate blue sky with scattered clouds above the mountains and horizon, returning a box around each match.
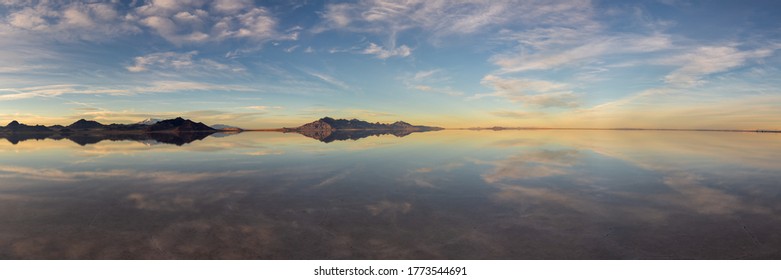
[0,0,781,129]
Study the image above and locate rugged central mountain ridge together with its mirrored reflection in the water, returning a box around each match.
[283,117,442,143]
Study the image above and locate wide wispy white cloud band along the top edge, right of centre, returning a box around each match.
[318,0,591,37]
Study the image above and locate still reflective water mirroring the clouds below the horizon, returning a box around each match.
[0,130,781,259]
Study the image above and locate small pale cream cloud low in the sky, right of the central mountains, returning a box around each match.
[472,75,580,108]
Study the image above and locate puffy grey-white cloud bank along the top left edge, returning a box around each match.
[0,0,286,45]
